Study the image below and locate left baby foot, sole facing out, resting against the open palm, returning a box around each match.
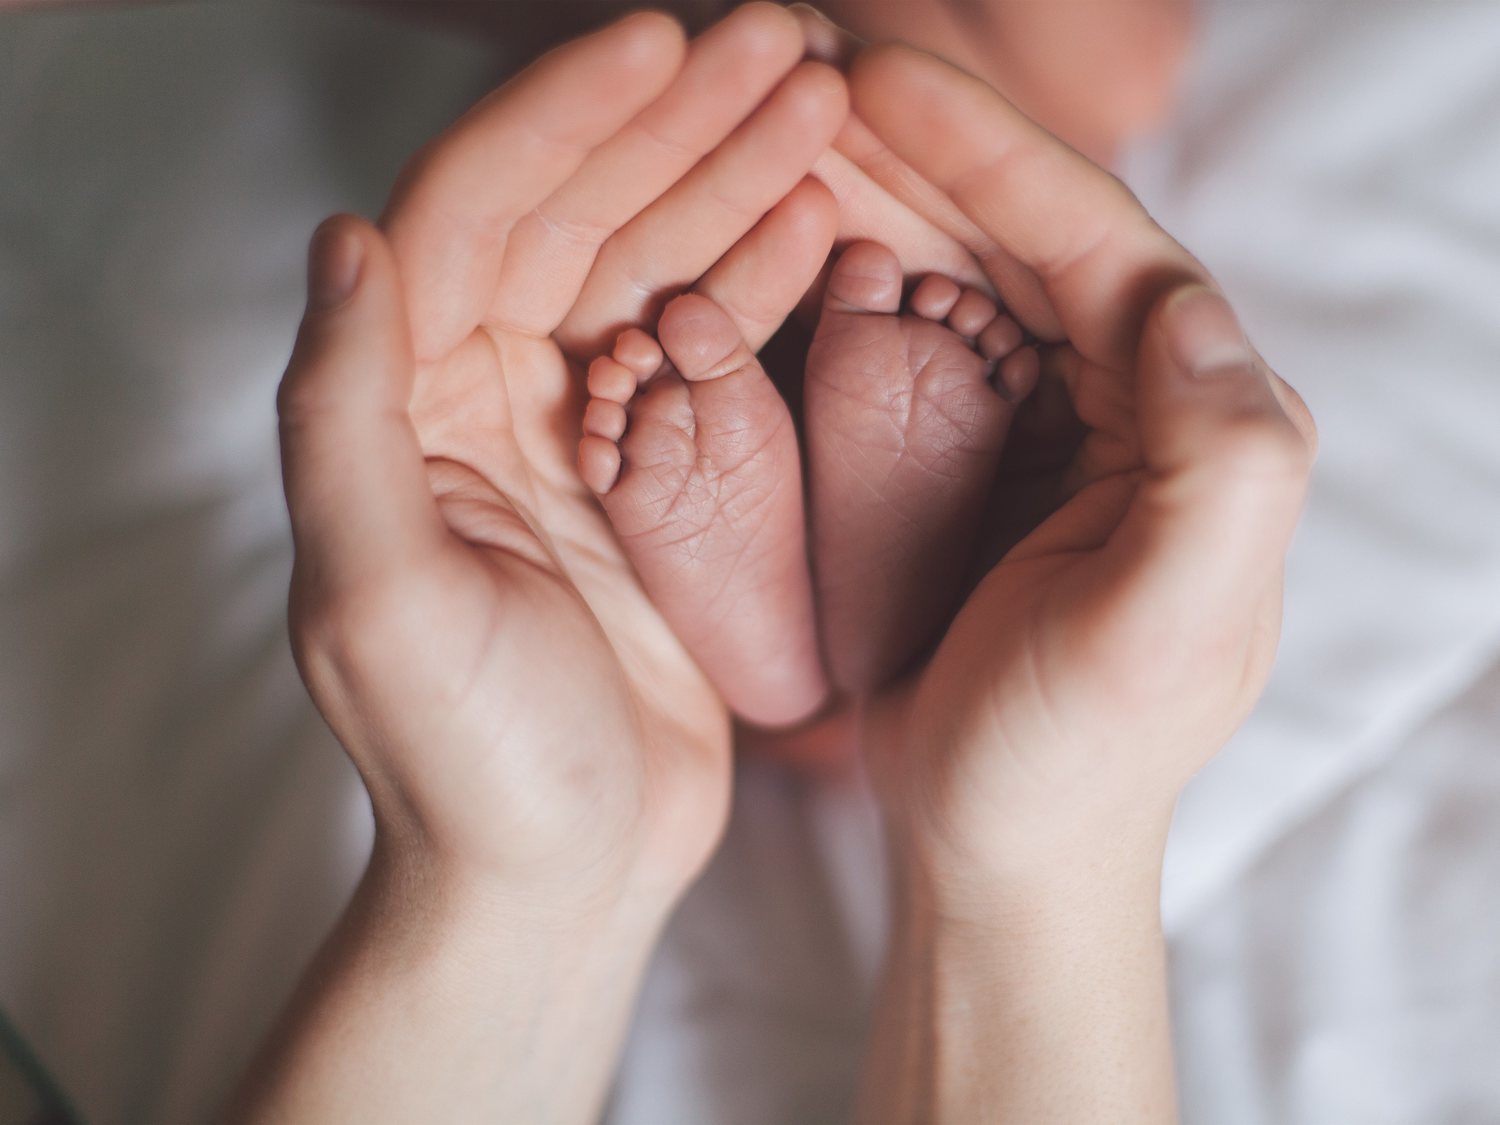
[579,294,828,726]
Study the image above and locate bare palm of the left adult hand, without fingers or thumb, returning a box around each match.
[393,327,729,888]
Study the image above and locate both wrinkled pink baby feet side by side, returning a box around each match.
[579,242,1038,728]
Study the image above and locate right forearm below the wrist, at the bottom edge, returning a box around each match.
[861,842,1175,1125]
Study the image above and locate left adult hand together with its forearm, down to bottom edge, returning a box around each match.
[223,6,845,1121]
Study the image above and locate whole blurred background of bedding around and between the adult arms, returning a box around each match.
[0,0,1500,1125]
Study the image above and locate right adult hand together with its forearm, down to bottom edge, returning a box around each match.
[851,48,1316,1122]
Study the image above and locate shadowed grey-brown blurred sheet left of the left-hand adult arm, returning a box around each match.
[0,5,498,1122]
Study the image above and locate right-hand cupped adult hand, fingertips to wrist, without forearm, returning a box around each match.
[851,48,1316,881]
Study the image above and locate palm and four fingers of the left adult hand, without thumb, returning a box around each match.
[337,6,876,882]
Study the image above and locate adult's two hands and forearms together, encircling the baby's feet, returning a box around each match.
[239,9,1313,1121]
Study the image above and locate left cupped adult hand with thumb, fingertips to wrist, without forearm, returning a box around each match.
[279,5,846,905]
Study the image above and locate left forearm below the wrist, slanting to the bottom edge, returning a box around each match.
[233,857,665,1122]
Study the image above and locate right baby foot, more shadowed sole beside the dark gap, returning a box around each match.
[806,243,1038,693]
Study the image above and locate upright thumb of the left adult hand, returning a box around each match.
[276,216,444,590]
